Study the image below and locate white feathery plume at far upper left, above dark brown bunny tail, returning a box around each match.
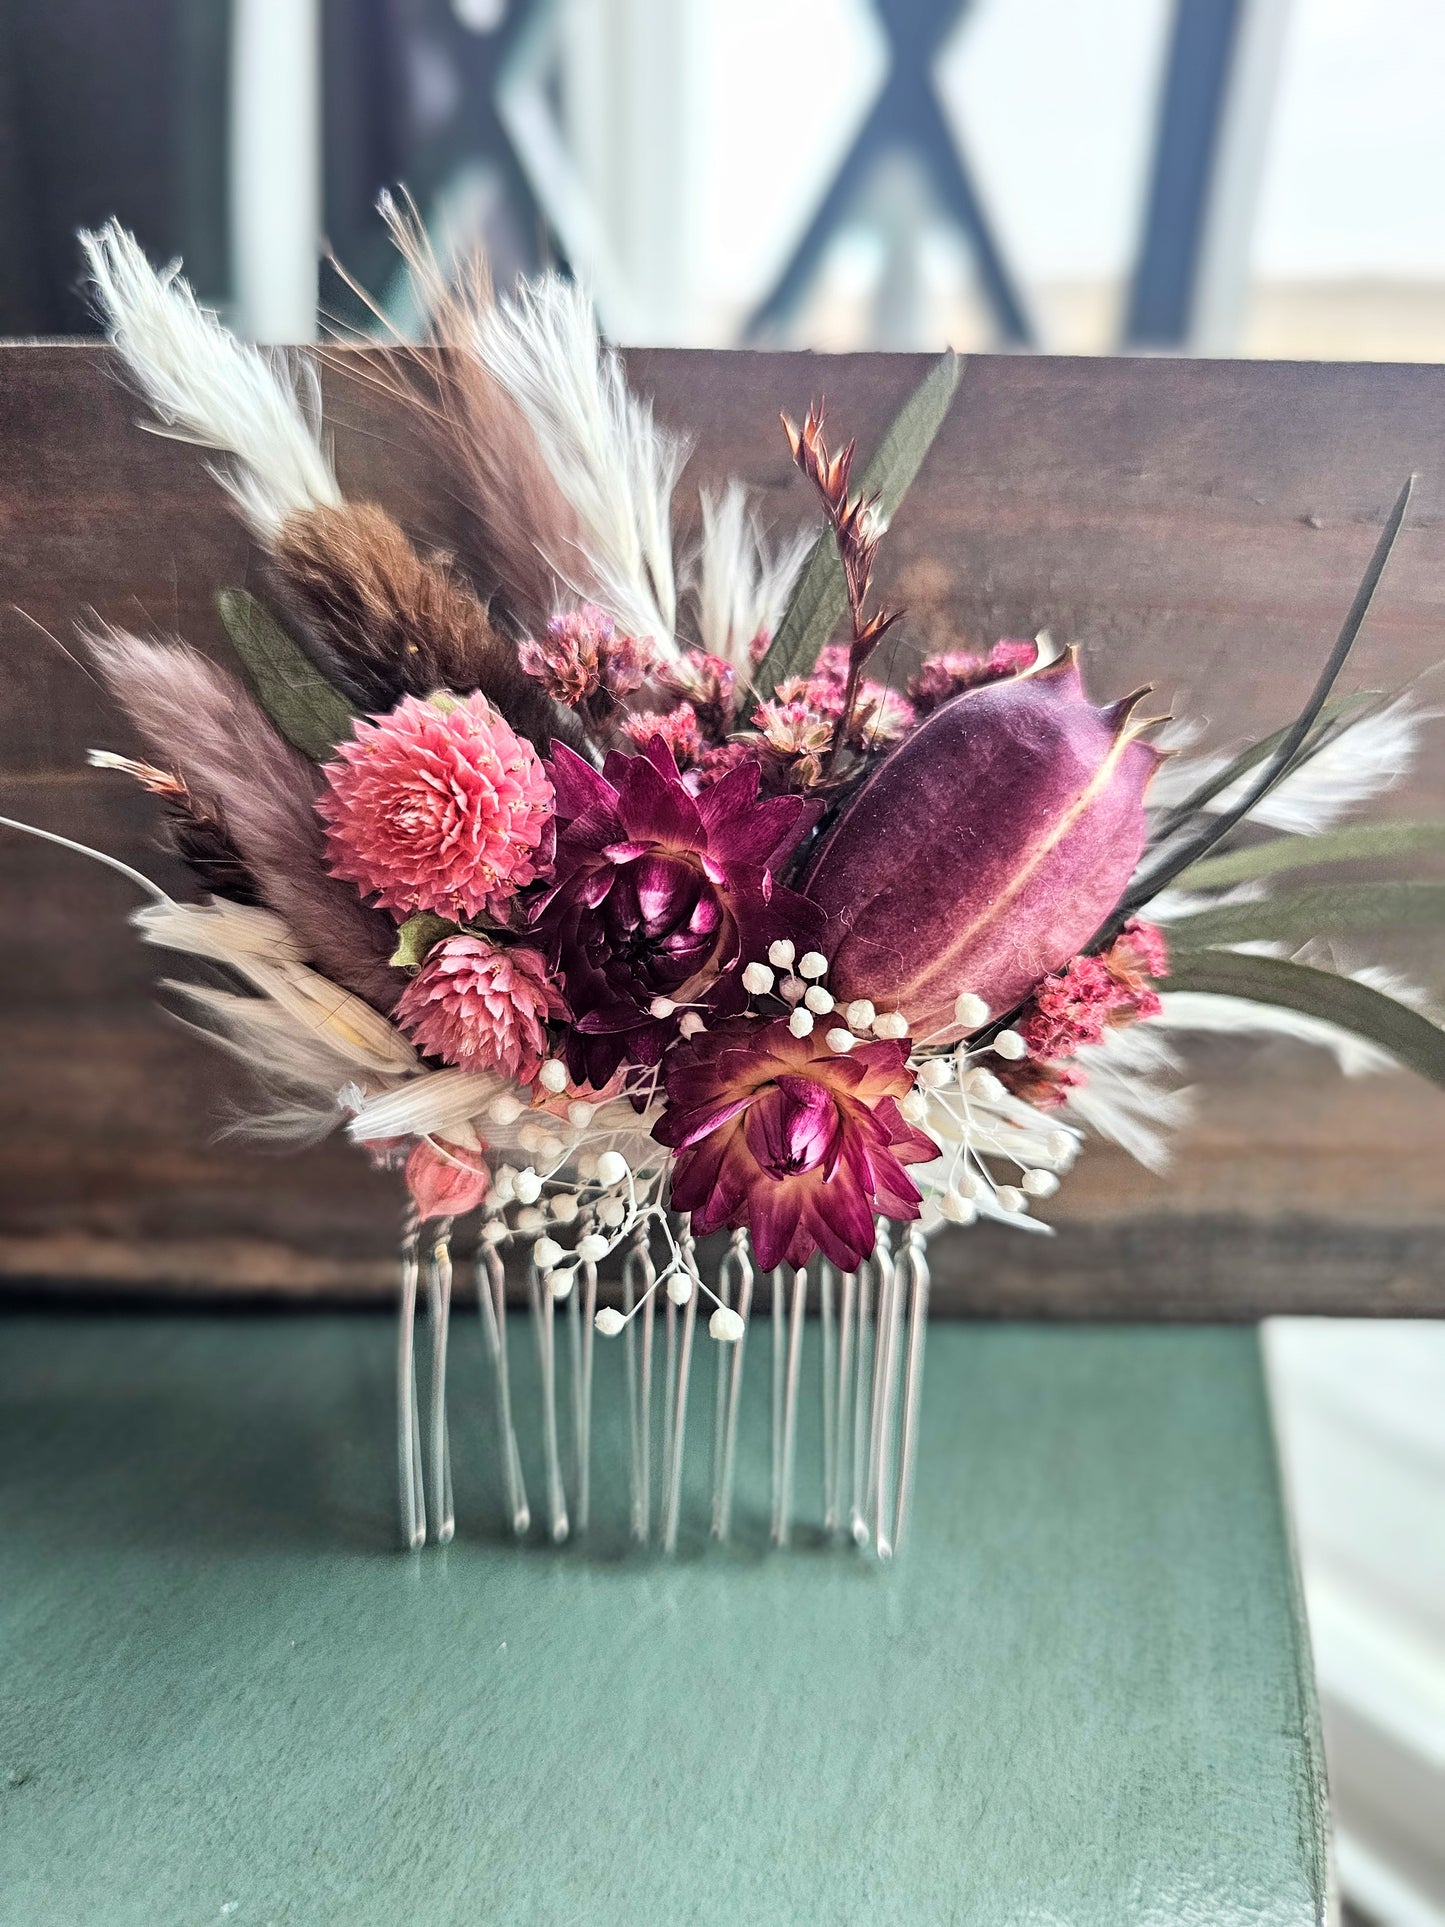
[81,222,341,540]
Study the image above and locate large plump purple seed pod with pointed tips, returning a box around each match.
[805,655,1160,1037]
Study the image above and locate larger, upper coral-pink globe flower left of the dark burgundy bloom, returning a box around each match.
[316,692,551,917]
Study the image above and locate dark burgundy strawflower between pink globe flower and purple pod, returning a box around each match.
[534,736,821,1089]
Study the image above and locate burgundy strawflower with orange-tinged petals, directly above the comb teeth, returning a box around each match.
[653,1017,938,1272]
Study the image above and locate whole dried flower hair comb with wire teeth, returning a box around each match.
[12,206,1445,1555]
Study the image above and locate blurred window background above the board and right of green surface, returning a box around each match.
[0,0,1445,1927]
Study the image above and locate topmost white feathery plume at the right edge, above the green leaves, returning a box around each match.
[1148,696,1445,836]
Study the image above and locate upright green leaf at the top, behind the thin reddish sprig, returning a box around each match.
[753,351,963,701]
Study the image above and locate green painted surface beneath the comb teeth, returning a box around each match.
[0,1316,1324,1927]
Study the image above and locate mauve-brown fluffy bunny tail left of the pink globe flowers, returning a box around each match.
[85,630,407,1012]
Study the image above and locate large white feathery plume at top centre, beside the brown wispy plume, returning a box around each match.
[476,274,688,653]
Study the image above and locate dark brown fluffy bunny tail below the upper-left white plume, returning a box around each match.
[272,503,570,750]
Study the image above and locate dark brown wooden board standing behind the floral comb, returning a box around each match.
[0,345,1445,1318]
